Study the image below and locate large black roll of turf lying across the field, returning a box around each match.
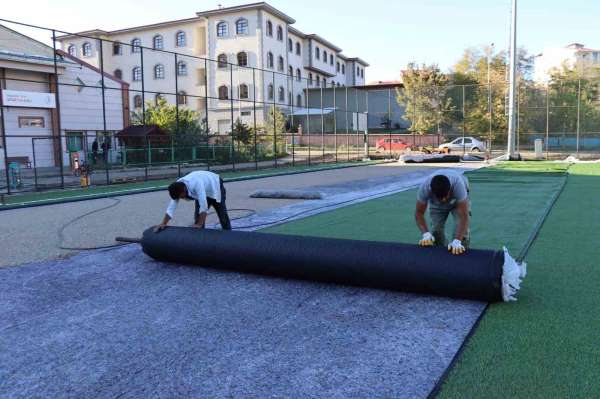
[142,227,504,302]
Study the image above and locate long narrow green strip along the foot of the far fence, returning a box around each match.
[0,161,381,210]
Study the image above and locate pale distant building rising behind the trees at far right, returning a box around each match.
[535,43,600,83]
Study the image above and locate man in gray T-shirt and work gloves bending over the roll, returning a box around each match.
[415,170,471,255]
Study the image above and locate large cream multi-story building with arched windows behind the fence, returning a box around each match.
[58,3,369,133]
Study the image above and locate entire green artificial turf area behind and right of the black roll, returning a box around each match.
[268,162,600,398]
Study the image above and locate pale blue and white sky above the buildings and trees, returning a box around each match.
[0,0,600,82]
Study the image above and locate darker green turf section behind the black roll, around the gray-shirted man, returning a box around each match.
[265,165,565,254]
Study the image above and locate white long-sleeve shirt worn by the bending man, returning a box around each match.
[167,170,221,218]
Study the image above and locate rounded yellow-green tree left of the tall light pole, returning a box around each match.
[396,63,451,134]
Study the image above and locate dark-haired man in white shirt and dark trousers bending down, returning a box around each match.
[154,171,231,232]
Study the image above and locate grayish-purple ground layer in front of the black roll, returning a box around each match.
[0,245,484,398]
